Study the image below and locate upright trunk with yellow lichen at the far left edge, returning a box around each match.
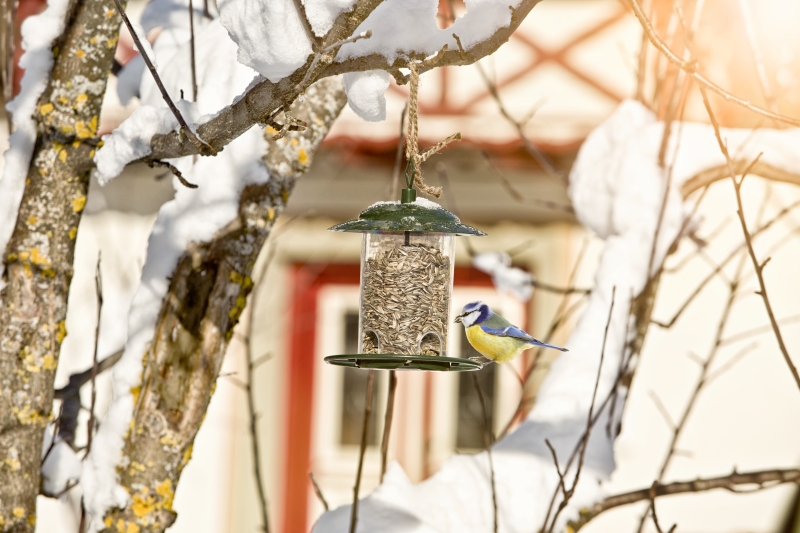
[0,0,121,532]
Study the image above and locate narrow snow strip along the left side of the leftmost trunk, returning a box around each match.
[0,0,69,290]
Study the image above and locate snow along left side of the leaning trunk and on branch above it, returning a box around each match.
[81,17,269,531]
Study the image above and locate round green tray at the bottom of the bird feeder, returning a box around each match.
[325,354,483,372]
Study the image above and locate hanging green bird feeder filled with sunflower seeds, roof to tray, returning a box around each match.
[325,188,485,371]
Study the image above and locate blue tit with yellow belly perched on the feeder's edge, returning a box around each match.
[456,302,567,363]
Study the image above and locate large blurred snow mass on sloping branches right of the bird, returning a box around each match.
[314,101,800,533]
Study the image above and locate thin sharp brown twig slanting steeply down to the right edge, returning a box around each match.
[696,85,800,388]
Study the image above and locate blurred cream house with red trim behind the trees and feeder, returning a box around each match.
[2,0,800,533]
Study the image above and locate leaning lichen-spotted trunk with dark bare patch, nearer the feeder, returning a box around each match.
[104,78,346,533]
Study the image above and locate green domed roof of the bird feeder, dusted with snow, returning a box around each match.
[329,198,486,237]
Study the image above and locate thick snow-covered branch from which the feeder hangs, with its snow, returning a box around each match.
[104,0,540,168]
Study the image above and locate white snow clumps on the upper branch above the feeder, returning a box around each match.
[209,0,520,122]
